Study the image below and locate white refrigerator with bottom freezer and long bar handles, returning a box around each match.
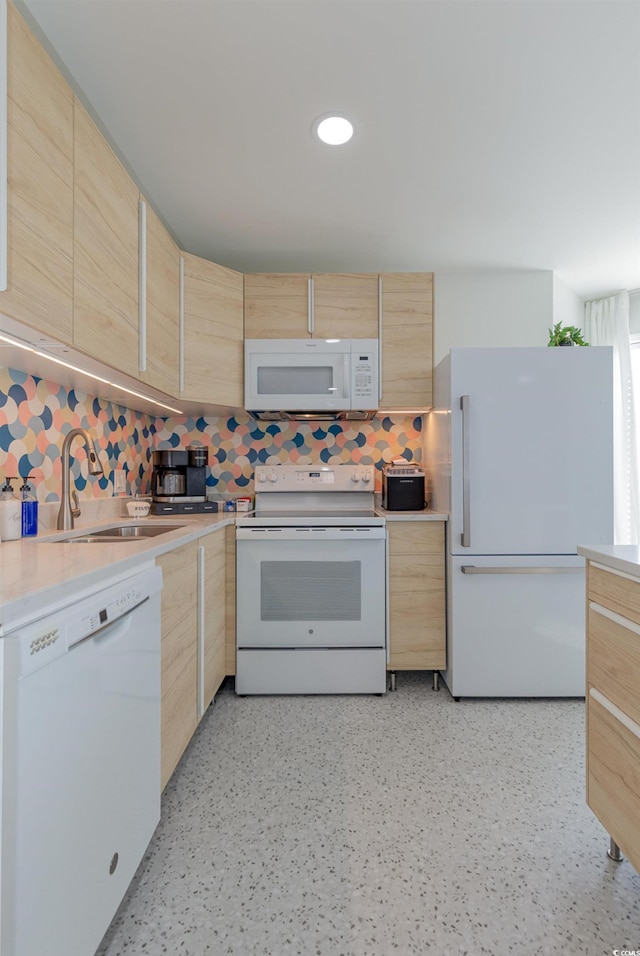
[425,346,613,698]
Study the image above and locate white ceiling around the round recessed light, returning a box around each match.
[18,0,640,297]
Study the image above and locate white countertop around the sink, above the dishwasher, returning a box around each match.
[0,512,236,637]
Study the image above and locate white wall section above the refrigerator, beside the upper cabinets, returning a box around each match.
[434,270,556,364]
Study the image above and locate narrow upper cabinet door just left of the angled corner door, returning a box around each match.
[140,203,180,395]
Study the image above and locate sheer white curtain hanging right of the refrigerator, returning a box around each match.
[585,292,640,544]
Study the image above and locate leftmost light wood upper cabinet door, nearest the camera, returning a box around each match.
[0,3,73,344]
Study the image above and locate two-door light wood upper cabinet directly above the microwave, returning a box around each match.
[244,273,379,339]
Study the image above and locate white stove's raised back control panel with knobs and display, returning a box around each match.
[255,465,374,492]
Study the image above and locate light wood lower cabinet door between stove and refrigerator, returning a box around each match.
[387,521,446,670]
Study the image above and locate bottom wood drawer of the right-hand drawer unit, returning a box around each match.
[587,695,640,869]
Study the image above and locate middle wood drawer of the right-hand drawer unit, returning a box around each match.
[587,605,640,724]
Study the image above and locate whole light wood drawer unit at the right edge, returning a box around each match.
[587,562,640,871]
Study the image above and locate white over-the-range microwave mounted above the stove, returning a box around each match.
[244,339,378,420]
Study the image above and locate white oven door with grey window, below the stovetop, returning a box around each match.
[236,527,386,650]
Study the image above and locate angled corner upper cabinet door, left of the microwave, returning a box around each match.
[186,253,244,408]
